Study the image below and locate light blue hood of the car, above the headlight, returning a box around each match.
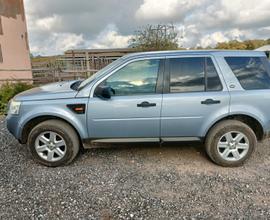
[14,80,78,101]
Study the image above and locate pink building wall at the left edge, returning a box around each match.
[0,0,32,82]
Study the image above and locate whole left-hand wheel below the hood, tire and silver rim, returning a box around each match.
[28,120,80,167]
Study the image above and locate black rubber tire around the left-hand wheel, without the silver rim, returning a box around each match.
[27,119,80,167]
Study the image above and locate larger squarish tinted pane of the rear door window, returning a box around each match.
[170,57,205,93]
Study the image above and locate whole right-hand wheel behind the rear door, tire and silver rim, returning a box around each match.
[205,120,257,167]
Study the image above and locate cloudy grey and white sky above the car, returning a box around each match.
[24,0,270,55]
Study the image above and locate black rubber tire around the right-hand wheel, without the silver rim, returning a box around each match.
[205,120,257,167]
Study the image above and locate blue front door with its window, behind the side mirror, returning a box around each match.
[87,59,163,142]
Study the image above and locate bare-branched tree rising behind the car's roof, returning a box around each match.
[130,24,178,51]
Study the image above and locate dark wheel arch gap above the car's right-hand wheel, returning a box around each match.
[205,114,265,141]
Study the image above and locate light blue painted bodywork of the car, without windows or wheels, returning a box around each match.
[6,51,270,146]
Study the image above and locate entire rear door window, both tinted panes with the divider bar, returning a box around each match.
[170,57,222,93]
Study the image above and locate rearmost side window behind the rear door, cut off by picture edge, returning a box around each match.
[225,57,270,90]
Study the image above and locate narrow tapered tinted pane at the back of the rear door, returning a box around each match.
[206,58,222,91]
